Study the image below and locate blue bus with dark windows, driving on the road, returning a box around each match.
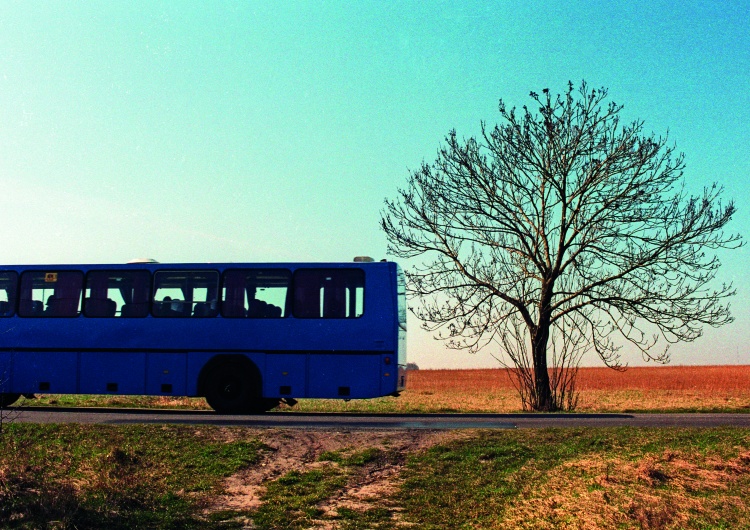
[0,258,406,414]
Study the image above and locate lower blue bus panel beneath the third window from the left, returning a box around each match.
[79,352,146,394]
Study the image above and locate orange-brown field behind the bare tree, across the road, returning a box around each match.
[382,366,750,412]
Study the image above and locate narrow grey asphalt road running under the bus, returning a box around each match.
[1,407,750,430]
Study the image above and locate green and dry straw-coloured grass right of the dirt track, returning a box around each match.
[401,428,750,529]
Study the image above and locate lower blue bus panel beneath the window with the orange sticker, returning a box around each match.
[11,351,78,394]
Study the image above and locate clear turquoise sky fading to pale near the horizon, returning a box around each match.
[0,0,750,368]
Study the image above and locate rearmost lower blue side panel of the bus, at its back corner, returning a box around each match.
[308,354,381,399]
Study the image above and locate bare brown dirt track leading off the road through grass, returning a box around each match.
[209,429,461,529]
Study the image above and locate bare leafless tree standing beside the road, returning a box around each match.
[381,82,742,411]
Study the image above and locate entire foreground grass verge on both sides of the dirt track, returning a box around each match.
[0,424,750,530]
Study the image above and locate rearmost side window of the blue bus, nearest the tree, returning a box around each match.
[294,269,365,318]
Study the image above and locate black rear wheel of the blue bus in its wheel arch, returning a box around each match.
[205,361,279,414]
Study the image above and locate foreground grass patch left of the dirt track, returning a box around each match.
[0,423,264,529]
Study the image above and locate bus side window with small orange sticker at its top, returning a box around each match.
[18,271,83,317]
